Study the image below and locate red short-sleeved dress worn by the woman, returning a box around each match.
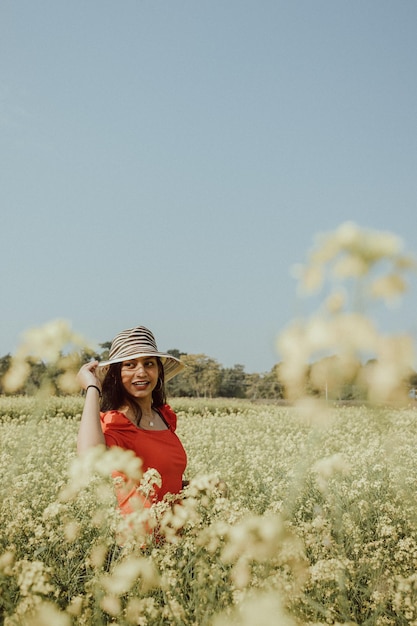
[100,404,187,513]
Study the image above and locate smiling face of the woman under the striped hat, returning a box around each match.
[120,356,159,401]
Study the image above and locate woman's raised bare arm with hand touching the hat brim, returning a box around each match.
[77,361,106,454]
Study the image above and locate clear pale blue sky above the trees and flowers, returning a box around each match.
[0,0,417,372]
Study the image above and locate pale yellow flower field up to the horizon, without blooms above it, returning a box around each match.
[0,396,417,626]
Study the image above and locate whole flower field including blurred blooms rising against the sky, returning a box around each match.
[0,222,417,626]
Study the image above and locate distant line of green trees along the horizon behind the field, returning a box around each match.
[0,342,417,401]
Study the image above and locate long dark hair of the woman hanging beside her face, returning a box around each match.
[101,357,166,420]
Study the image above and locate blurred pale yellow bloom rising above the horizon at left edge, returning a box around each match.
[3,319,89,393]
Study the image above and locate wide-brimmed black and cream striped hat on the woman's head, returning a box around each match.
[98,326,184,380]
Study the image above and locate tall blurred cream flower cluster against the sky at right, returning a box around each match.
[278,222,416,403]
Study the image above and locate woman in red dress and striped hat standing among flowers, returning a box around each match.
[77,326,187,513]
